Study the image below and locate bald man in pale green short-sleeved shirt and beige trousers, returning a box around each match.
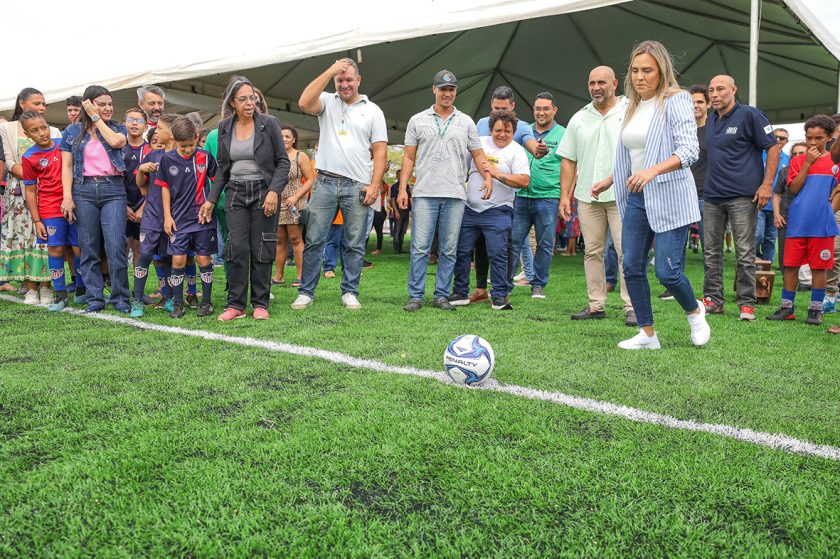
[557,66,637,326]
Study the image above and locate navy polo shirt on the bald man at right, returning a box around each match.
[703,103,776,203]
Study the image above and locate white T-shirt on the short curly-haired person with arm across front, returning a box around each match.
[467,136,531,213]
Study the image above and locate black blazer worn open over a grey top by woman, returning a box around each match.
[208,113,290,203]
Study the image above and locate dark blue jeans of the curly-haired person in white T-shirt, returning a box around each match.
[452,206,513,301]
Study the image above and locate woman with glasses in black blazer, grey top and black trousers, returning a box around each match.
[199,76,289,321]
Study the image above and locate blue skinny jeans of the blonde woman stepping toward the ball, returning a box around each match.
[621,192,697,326]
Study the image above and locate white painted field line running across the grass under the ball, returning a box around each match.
[0,294,840,461]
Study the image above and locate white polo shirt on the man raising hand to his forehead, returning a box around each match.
[315,91,388,186]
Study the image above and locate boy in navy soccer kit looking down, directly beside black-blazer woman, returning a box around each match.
[155,117,217,318]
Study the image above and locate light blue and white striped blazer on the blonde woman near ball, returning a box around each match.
[613,91,700,233]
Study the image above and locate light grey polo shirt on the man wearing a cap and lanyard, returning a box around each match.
[405,105,481,200]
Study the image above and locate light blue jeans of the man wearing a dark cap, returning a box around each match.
[408,197,465,301]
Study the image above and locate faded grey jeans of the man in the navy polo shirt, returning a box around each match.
[703,196,757,307]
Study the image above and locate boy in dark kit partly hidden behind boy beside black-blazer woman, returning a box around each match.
[129,114,178,318]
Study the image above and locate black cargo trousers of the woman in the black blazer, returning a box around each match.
[224,180,278,310]
